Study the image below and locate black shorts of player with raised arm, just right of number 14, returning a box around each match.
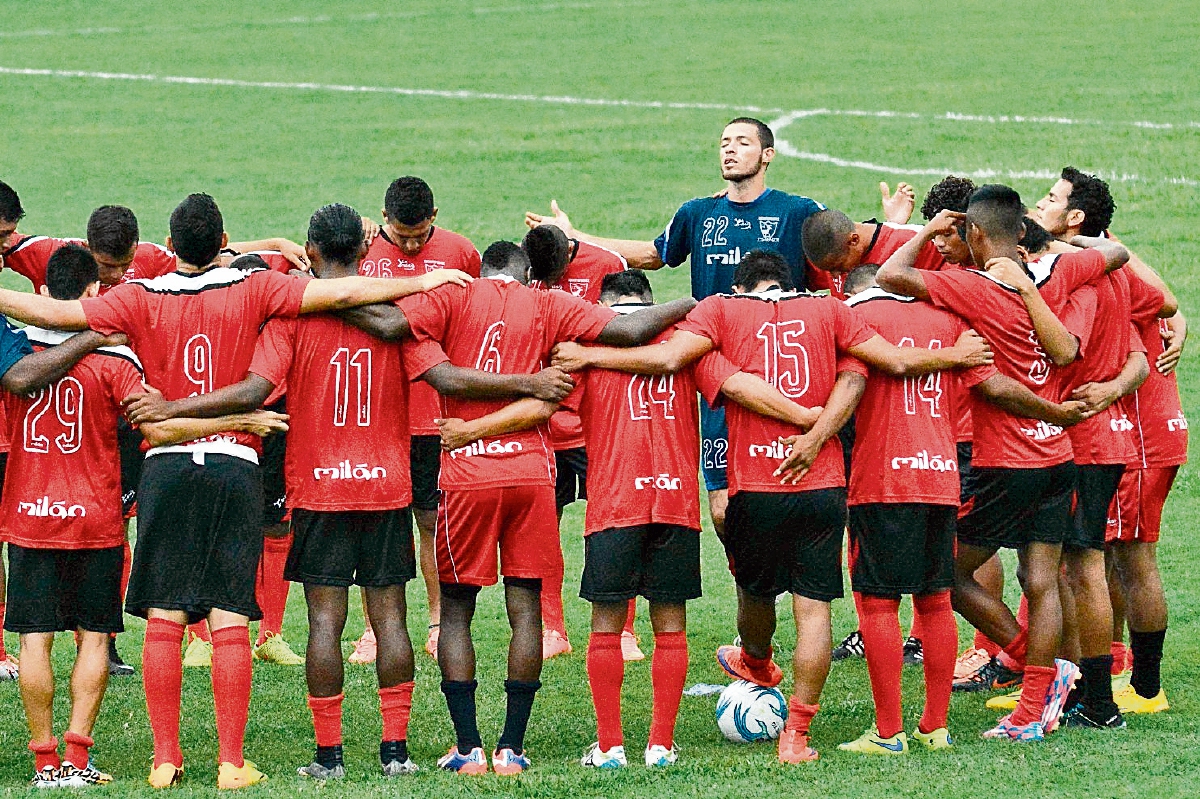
[959,461,1075,549]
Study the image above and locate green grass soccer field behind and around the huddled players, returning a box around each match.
[0,0,1200,798]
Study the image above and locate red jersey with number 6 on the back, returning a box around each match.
[400,276,616,489]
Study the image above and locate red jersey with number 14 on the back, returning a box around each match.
[846,288,996,506]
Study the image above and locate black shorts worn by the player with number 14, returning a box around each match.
[850,503,959,596]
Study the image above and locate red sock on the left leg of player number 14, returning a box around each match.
[854,591,904,738]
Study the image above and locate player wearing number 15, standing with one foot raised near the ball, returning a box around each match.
[556,251,989,763]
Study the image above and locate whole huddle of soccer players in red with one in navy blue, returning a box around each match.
[0,118,1187,788]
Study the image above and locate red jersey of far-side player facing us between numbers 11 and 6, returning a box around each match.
[359,228,479,435]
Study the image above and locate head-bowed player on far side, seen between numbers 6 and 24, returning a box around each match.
[521,224,628,661]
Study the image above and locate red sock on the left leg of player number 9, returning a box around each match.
[142,619,184,768]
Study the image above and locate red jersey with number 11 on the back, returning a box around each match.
[250,314,413,511]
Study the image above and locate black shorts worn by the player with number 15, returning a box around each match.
[725,488,846,602]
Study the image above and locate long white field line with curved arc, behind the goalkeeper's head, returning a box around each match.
[0,66,1200,186]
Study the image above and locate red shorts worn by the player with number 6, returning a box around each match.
[433,486,563,585]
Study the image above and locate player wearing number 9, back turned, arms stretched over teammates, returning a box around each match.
[0,194,469,788]
